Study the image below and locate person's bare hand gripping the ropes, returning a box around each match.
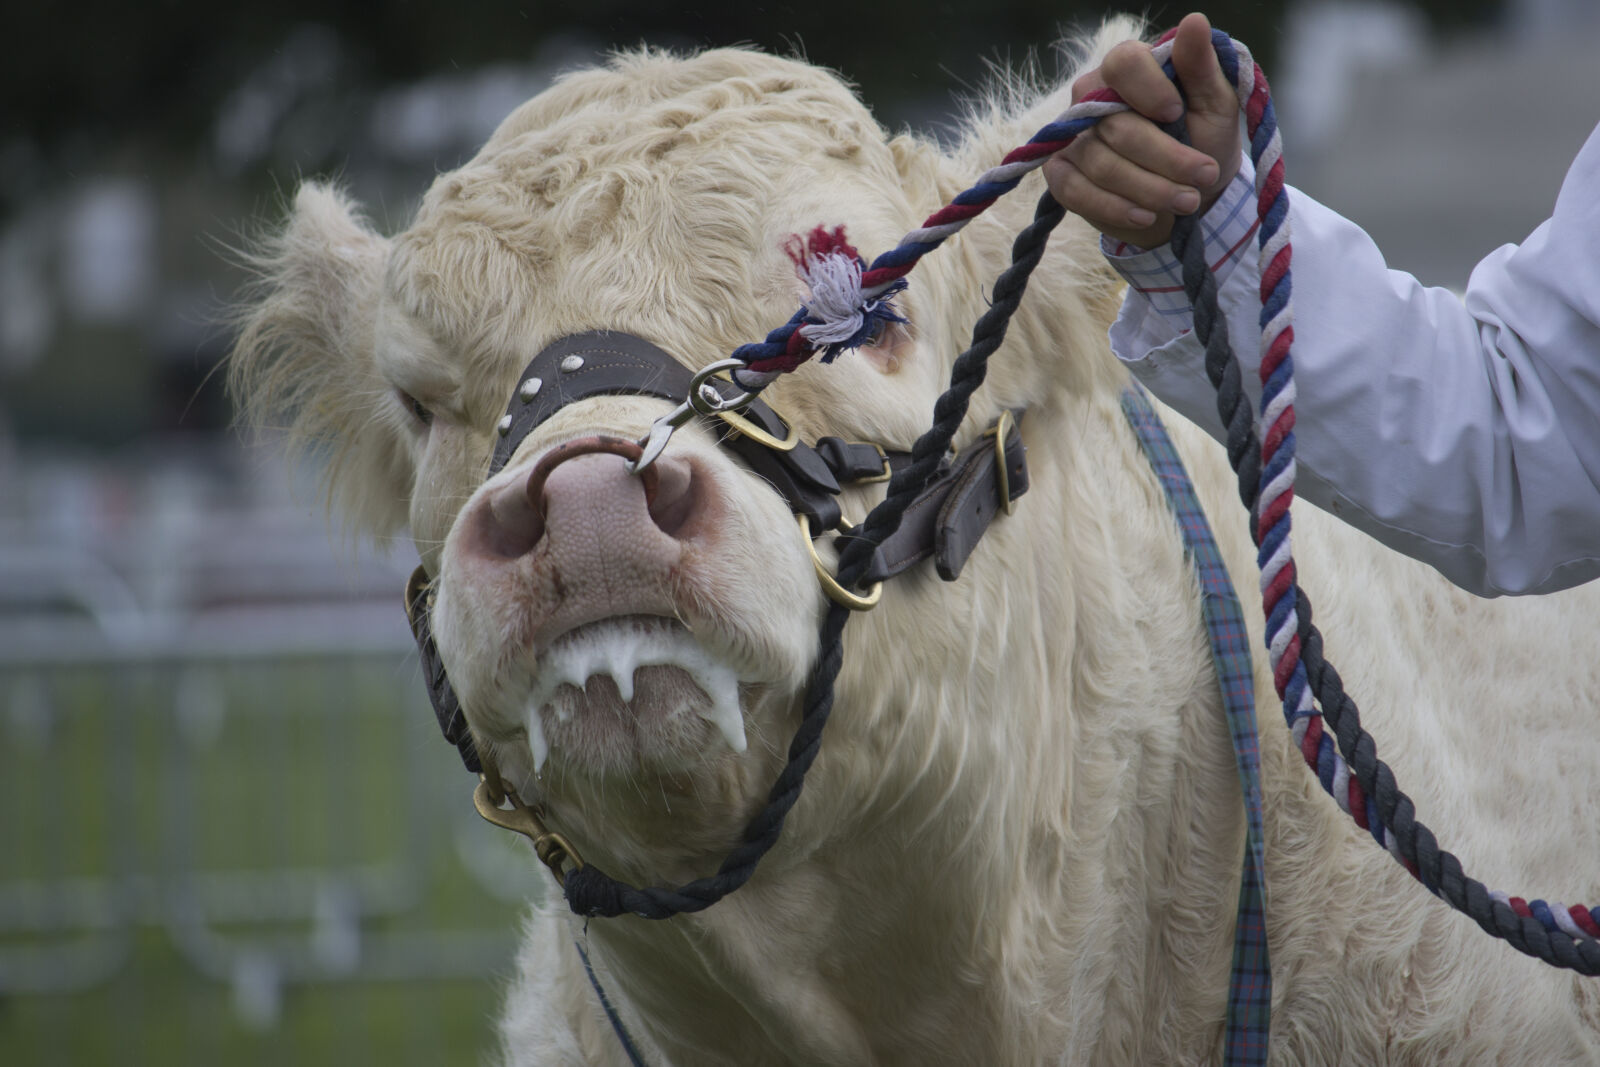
[1045,13,1240,248]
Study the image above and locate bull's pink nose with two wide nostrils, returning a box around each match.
[469,437,694,565]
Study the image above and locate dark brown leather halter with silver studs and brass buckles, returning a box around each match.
[405,330,1027,774]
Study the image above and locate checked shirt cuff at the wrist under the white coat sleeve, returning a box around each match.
[1101,158,1261,323]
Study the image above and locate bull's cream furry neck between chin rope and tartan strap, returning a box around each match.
[576,390,1243,1062]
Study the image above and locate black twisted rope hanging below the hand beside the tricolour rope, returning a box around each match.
[1170,154,1600,976]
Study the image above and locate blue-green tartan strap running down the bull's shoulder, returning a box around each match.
[1122,386,1272,1067]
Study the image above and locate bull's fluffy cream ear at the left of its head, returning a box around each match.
[229,182,410,534]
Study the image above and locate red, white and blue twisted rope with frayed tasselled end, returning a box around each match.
[733,30,1600,959]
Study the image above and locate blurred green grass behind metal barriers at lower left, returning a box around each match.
[0,656,542,1067]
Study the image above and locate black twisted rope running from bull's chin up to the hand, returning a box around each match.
[563,192,1064,918]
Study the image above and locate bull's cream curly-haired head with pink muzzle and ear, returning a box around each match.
[234,51,1115,902]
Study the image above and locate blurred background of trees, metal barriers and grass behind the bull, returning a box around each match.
[0,0,1600,1065]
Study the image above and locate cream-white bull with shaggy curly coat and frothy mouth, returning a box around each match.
[234,24,1600,1065]
